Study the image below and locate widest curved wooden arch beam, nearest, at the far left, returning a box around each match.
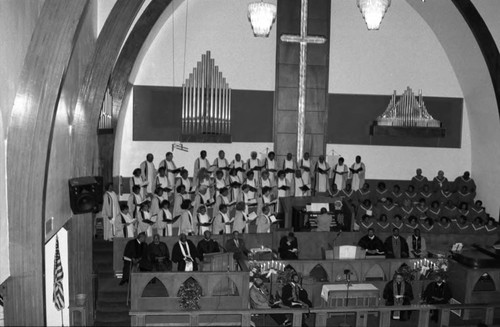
[5,0,88,326]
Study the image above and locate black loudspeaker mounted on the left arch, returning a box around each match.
[68,176,102,215]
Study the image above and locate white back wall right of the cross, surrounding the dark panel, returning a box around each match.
[327,0,471,179]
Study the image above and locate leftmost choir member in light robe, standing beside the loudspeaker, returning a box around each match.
[102,183,123,241]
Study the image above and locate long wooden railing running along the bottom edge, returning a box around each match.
[130,303,500,327]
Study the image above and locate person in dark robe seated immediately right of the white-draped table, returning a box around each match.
[383,272,413,321]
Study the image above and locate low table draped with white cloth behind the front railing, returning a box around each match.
[321,283,379,308]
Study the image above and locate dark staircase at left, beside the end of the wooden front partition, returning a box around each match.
[93,239,130,326]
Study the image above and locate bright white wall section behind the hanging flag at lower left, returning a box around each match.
[45,228,69,326]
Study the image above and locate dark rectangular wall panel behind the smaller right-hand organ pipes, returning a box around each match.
[327,94,463,148]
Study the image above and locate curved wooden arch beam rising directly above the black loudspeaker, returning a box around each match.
[72,0,144,177]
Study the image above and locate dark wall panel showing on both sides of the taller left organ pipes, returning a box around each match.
[133,86,274,142]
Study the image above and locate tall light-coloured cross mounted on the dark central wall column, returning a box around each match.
[281,0,326,160]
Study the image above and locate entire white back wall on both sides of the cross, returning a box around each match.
[114,0,471,187]
